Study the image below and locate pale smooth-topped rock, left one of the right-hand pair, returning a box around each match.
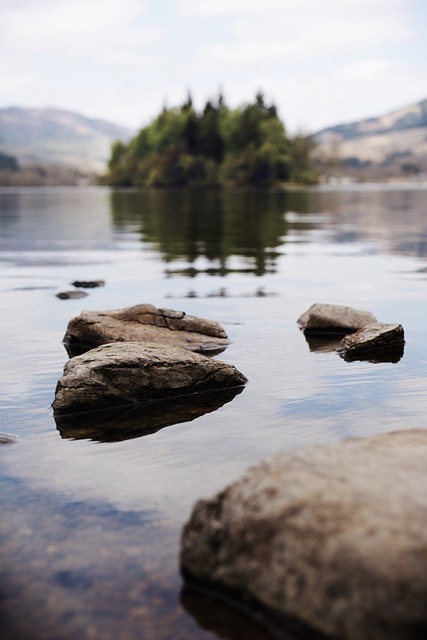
[297,303,377,333]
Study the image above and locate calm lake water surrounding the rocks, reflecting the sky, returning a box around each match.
[0,185,427,640]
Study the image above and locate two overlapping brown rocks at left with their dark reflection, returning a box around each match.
[52,304,247,441]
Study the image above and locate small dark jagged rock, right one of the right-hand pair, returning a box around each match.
[336,322,405,362]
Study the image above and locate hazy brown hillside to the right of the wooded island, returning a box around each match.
[315,100,427,177]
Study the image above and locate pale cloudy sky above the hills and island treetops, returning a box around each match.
[0,0,427,133]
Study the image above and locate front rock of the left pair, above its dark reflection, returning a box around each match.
[52,342,247,414]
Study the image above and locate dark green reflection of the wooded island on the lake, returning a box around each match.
[111,190,300,276]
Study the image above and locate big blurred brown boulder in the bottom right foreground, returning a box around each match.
[180,430,427,640]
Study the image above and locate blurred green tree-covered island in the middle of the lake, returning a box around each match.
[104,93,317,187]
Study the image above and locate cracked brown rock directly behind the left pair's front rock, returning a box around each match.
[64,304,229,355]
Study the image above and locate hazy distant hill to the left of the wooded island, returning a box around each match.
[0,107,135,172]
